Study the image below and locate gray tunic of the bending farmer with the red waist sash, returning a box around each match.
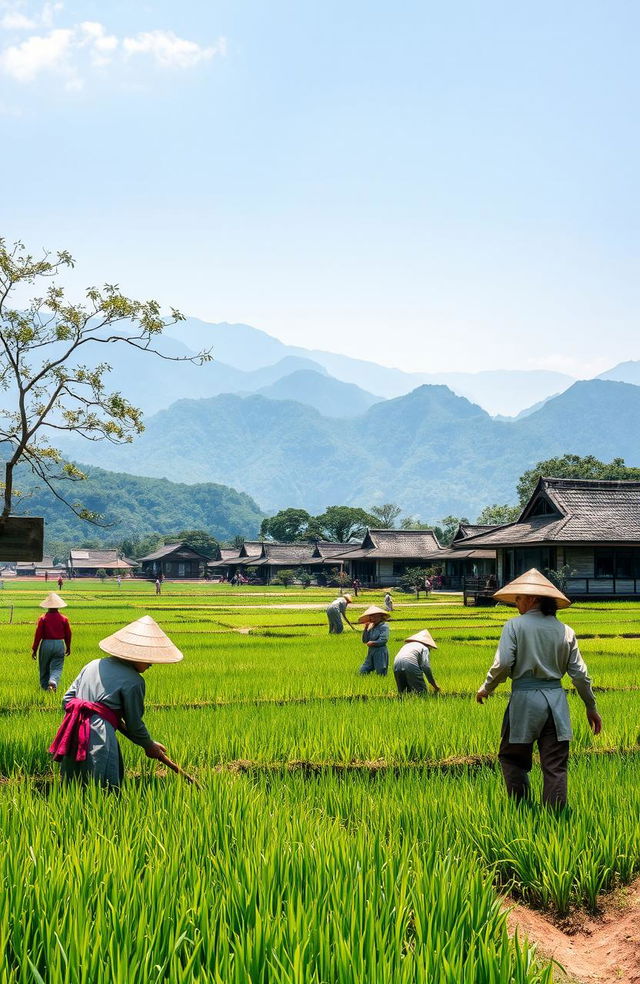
[60,656,152,787]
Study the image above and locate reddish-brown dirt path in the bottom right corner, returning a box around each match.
[509,879,640,984]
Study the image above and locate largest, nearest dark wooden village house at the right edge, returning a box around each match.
[465,478,640,598]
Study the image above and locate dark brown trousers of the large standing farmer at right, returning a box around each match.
[498,708,569,807]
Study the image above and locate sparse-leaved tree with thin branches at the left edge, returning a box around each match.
[0,238,211,522]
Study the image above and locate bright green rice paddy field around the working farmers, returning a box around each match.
[0,581,640,984]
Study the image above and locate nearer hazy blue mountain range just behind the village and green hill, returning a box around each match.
[57,379,640,520]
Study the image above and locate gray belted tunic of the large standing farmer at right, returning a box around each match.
[484,609,596,744]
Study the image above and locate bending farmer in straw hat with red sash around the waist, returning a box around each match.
[49,615,182,789]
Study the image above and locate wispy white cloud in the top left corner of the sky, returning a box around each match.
[0,0,226,89]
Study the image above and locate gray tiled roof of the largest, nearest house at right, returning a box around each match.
[465,478,640,547]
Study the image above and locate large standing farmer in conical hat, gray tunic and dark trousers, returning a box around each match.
[476,568,602,807]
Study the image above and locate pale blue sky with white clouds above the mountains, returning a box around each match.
[0,0,640,377]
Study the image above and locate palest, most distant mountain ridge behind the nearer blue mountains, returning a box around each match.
[90,318,575,417]
